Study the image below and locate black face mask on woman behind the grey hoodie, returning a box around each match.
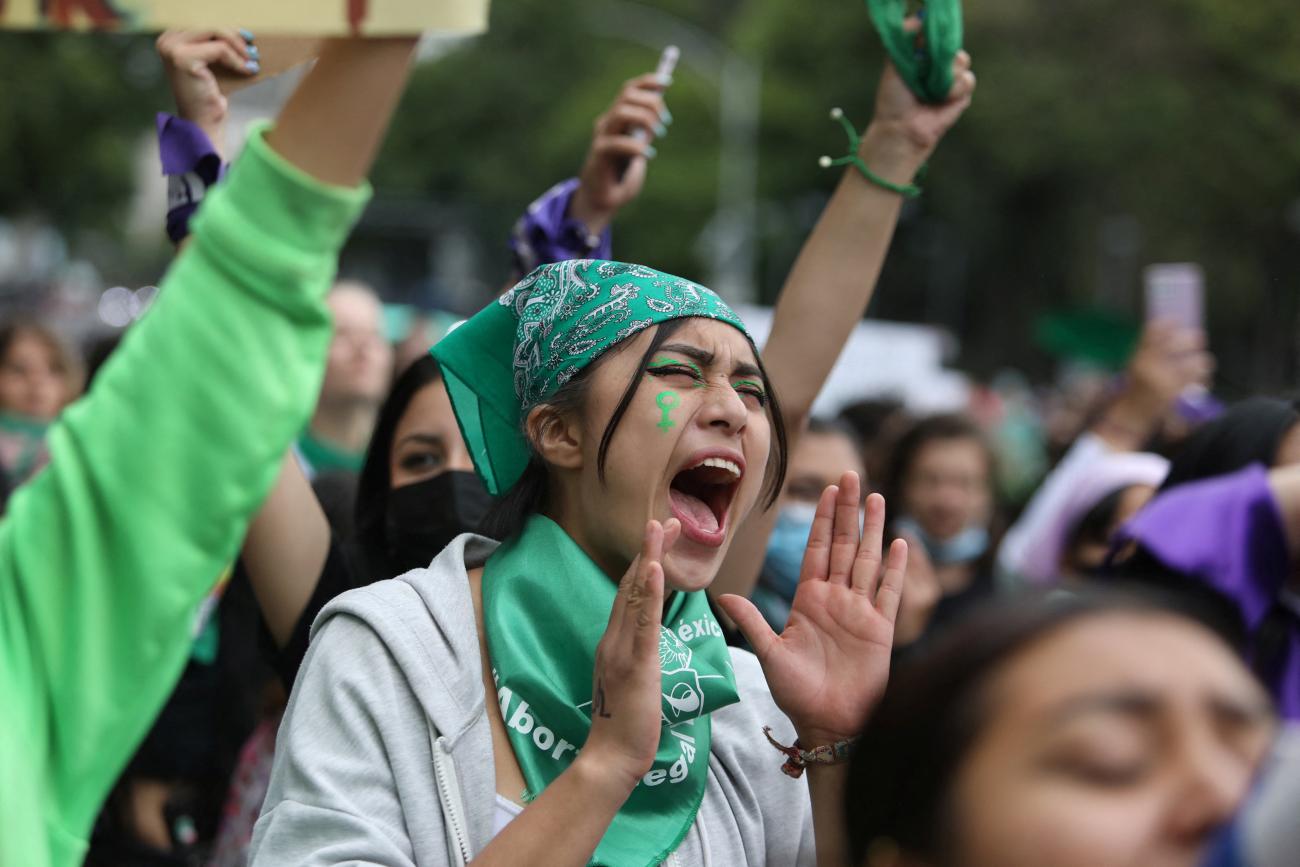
[384,469,493,575]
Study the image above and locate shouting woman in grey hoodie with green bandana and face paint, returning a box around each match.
[252,260,906,864]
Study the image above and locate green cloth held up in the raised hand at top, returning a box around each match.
[867,0,962,104]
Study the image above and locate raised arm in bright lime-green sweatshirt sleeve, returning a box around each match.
[0,33,413,863]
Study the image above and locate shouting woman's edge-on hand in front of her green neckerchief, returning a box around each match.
[582,519,681,793]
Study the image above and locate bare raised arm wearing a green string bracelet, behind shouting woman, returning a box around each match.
[710,52,975,608]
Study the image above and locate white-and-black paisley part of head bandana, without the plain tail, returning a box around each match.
[499,259,745,412]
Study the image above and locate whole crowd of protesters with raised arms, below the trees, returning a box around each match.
[0,20,1300,867]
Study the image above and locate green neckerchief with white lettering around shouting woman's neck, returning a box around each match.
[482,515,740,867]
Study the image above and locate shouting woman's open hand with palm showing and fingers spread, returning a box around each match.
[719,473,907,749]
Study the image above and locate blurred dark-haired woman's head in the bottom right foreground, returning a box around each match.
[845,595,1278,867]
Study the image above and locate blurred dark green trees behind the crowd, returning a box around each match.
[0,0,1300,394]
